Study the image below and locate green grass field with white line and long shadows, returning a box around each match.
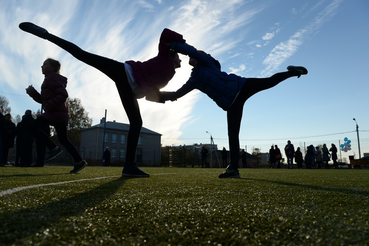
[0,166,369,245]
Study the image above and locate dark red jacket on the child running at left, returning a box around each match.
[29,72,69,125]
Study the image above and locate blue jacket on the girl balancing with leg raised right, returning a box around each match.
[170,42,246,111]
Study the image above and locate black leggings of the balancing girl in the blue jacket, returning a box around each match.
[227,71,298,170]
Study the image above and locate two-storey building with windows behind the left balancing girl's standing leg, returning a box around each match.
[80,118,161,166]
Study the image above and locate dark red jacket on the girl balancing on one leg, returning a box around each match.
[126,28,186,95]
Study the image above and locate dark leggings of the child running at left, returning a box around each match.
[30,116,82,163]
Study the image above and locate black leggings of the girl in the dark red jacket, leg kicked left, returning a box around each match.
[47,34,142,166]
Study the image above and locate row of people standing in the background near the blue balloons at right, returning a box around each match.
[269,140,338,169]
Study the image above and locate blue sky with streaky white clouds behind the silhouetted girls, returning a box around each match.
[0,0,369,160]
